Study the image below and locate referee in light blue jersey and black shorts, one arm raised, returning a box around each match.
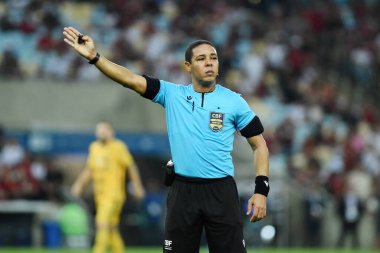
[63,27,269,253]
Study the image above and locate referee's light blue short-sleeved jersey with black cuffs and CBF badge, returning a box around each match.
[143,76,263,178]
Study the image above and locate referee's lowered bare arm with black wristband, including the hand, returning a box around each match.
[247,134,269,222]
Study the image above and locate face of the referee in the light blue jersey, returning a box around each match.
[185,44,219,87]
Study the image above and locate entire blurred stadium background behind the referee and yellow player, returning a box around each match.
[0,0,380,249]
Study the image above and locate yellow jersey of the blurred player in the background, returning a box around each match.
[87,139,134,202]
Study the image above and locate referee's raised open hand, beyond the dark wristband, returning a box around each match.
[63,27,96,60]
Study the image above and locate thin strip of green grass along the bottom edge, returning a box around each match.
[0,247,379,253]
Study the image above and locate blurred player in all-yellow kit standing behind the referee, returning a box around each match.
[71,122,145,253]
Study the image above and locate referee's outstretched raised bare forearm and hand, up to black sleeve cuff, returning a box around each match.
[63,27,147,95]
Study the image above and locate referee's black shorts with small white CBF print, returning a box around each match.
[163,176,247,253]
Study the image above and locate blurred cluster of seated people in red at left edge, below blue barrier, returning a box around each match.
[0,128,64,202]
